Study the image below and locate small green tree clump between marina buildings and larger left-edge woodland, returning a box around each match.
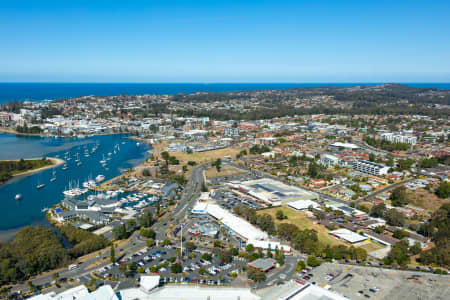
[59,224,108,257]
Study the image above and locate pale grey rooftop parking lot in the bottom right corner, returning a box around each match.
[308,263,450,300]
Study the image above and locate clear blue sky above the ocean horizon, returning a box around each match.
[0,0,450,83]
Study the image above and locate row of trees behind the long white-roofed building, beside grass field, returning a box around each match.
[234,206,367,260]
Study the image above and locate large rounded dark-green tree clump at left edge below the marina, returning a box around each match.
[0,226,70,285]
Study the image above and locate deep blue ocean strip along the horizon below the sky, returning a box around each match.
[0,82,450,103]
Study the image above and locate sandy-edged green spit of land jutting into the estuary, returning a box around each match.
[0,157,64,185]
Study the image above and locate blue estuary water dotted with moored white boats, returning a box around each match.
[0,134,150,240]
